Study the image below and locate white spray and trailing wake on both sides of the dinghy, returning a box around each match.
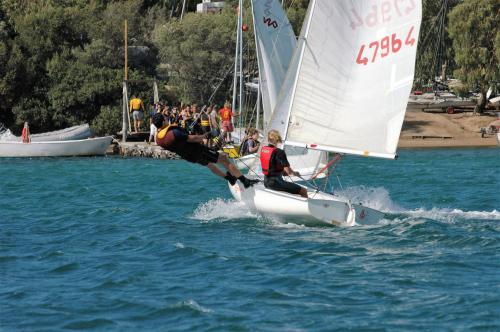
[192,186,500,224]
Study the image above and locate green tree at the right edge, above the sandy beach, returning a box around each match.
[449,0,500,112]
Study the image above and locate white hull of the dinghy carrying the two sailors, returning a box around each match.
[229,182,384,225]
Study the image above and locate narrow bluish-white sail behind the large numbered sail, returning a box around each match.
[252,0,297,128]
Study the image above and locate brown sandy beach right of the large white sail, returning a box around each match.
[398,111,498,148]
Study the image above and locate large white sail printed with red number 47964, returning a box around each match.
[271,0,421,158]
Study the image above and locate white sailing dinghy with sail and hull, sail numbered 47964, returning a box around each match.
[230,0,422,225]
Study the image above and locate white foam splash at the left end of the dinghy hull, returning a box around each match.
[192,198,258,221]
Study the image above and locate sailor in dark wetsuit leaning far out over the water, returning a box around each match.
[153,114,258,188]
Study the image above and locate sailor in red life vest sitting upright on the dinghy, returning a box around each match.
[260,129,307,197]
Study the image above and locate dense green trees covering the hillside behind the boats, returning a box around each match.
[0,0,500,134]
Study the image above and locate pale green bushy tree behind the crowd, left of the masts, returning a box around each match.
[154,6,236,103]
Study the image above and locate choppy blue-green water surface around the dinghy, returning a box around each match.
[0,148,500,331]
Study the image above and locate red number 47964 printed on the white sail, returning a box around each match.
[356,27,416,66]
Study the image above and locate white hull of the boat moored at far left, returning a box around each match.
[0,136,113,157]
